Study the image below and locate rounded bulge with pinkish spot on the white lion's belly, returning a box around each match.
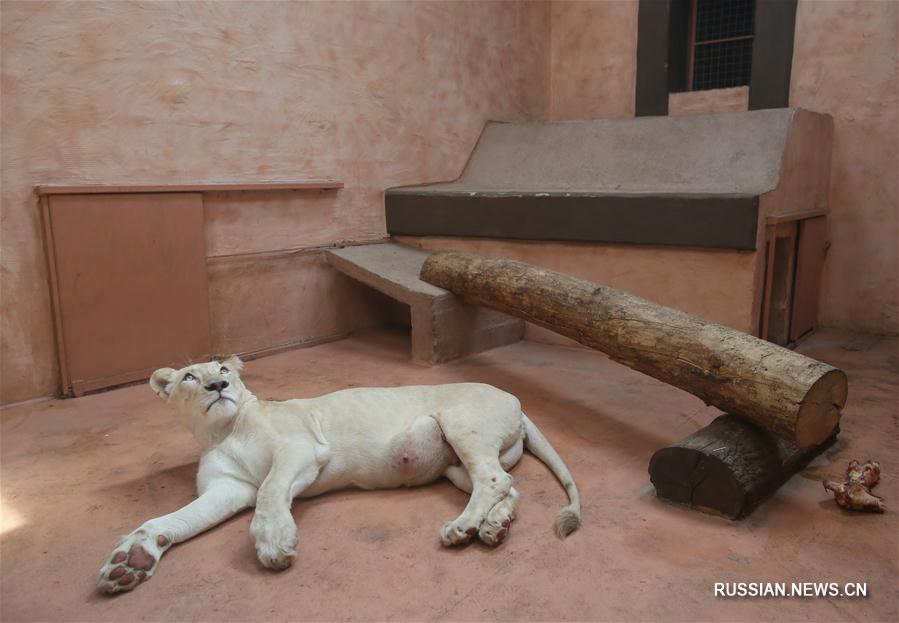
[386,415,459,486]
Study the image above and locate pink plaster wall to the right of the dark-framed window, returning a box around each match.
[790,0,899,334]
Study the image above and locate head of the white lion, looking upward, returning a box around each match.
[150,355,251,420]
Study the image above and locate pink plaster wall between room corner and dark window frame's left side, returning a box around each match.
[549,0,639,121]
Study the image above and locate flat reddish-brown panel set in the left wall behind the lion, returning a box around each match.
[46,193,211,395]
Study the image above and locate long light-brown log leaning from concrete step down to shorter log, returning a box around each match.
[421,252,847,447]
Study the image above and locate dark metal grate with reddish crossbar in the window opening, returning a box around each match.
[689,0,755,91]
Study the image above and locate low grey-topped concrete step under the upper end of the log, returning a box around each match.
[326,242,524,364]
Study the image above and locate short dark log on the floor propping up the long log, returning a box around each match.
[649,415,839,519]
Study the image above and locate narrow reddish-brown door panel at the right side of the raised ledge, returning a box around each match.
[790,216,827,340]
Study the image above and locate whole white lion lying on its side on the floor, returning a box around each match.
[99,356,581,593]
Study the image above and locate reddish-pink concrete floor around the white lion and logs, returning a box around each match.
[0,331,899,621]
